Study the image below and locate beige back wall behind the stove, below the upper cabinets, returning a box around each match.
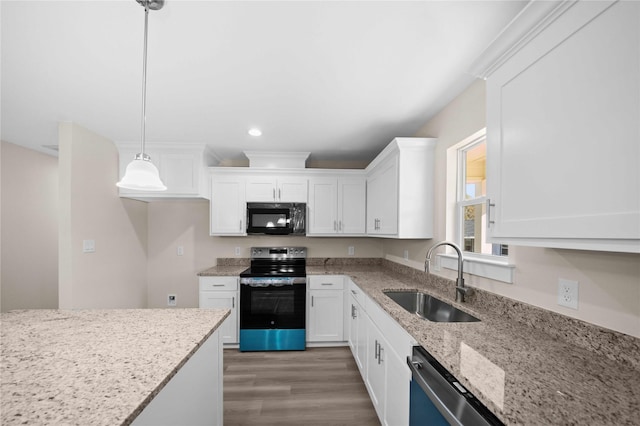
[148,201,382,308]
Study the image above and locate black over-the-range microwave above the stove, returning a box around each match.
[247,203,307,235]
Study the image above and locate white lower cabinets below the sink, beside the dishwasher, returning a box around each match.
[349,282,415,426]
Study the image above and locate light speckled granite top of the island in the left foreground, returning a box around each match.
[0,309,230,426]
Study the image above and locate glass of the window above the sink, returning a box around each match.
[456,134,508,256]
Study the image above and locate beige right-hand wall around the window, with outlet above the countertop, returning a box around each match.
[384,80,640,337]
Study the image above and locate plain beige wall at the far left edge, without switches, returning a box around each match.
[0,141,58,312]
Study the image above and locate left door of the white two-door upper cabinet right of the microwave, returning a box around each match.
[307,178,338,235]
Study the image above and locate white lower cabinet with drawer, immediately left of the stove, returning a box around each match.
[199,277,240,344]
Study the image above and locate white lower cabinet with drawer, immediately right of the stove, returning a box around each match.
[307,275,345,342]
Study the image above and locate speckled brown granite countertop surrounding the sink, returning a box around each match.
[307,266,640,426]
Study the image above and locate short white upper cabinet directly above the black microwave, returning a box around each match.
[247,173,307,203]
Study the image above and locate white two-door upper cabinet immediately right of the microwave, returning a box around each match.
[307,172,366,236]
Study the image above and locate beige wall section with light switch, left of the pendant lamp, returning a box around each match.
[59,123,147,309]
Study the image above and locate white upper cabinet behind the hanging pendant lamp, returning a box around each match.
[118,144,212,201]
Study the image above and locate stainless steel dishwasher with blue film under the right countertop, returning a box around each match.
[407,346,504,426]
